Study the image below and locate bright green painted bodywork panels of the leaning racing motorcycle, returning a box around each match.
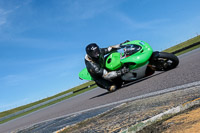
[79,40,153,80]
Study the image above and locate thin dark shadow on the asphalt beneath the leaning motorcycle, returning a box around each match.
[90,71,165,99]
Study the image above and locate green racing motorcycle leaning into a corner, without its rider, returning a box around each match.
[79,40,179,90]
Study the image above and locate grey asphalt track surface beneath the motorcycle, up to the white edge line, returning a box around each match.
[0,49,200,133]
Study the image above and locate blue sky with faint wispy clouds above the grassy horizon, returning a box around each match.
[0,0,200,112]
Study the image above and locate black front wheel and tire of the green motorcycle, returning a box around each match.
[151,52,179,71]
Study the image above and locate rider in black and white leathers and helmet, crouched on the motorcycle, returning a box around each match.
[85,40,129,91]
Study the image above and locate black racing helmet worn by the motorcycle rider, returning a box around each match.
[86,43,100,60]
